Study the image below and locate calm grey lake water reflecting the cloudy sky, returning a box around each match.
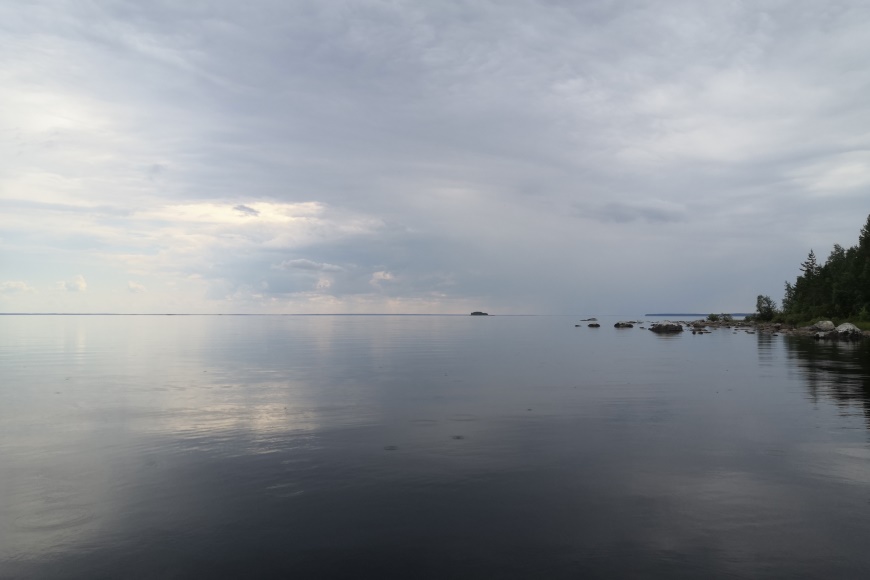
[0,316,870,579]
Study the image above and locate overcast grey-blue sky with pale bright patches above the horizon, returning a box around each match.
[0,0,870,314]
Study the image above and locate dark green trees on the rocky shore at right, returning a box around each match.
[756,216,870,323]
